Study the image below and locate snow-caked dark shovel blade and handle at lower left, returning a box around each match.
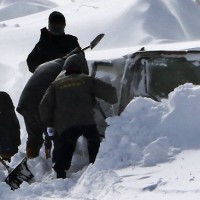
[0,157,34,190]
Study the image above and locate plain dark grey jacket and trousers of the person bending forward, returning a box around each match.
[17,55,88,153]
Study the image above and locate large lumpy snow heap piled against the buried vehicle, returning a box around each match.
[95,83,200,169]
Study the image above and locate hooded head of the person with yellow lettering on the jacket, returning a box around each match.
[63,53,87,75]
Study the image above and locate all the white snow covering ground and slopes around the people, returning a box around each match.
[0,0,200,200]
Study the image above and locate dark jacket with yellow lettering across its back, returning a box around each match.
[40,74,117,135]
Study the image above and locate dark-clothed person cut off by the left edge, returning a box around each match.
[0,91,21,161]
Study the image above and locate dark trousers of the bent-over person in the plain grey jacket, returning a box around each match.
[23,112,52,150]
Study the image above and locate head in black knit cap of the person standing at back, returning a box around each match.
[48,11,66,35]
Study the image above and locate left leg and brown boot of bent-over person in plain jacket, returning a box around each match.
[23,112,44,158]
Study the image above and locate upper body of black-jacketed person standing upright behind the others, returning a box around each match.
[27,11,80,73]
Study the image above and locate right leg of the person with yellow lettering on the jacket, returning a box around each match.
[83,125,100,163]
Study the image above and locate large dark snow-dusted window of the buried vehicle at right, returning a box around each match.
[145,57,200,98]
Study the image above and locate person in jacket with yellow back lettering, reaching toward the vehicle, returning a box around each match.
[39,54,117,178]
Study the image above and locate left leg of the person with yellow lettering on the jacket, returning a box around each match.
[52,127,81,178]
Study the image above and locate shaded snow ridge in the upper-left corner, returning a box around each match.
[0,0,58,21]
